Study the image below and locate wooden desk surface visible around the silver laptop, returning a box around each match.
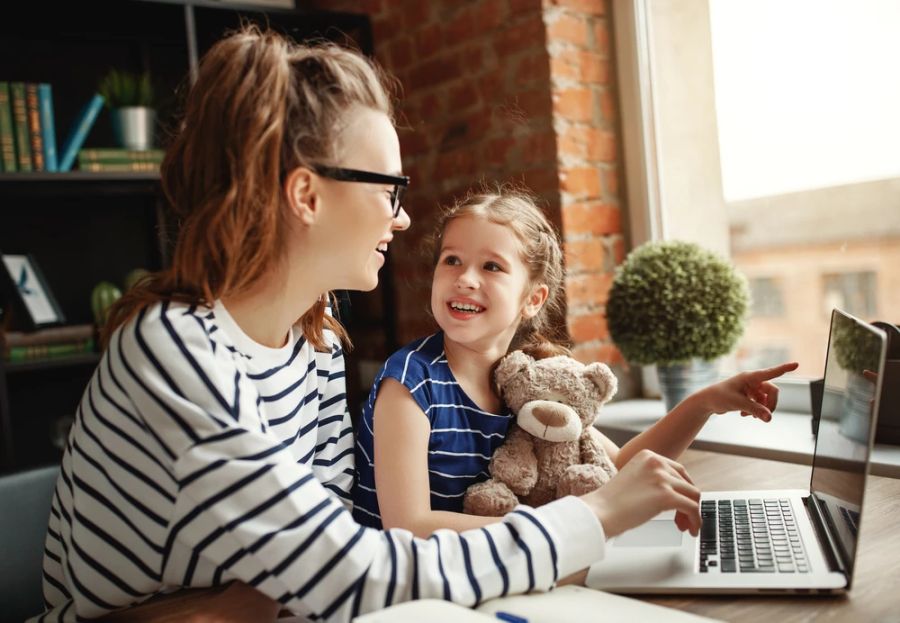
[644,450,900,623]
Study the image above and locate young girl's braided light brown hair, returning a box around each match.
[429,187,570,359]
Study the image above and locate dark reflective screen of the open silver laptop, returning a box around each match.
[810,309,887,577]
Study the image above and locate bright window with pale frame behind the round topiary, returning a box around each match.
[613,0,900,378]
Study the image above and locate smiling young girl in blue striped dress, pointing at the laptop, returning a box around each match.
[353,192,796,537]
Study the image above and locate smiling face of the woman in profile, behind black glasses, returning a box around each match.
[319,107,410,291]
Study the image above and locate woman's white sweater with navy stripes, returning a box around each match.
[36,304,603,621]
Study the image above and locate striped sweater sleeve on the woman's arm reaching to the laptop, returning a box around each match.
[118,302,604,620]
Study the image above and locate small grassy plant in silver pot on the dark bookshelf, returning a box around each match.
[97,69,156,150]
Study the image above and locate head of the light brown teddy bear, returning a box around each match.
[494,350,618,442]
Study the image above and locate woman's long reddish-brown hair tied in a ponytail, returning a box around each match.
[104,25,393,348]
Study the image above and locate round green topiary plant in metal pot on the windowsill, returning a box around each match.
[606,241,749,410]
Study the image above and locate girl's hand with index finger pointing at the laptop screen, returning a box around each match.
[697,362,799,422]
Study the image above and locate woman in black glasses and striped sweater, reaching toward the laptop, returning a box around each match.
[42,28,712,621]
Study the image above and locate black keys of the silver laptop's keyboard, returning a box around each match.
[700,498,809,573]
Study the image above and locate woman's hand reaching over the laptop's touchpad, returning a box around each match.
[581,450,700,538]
